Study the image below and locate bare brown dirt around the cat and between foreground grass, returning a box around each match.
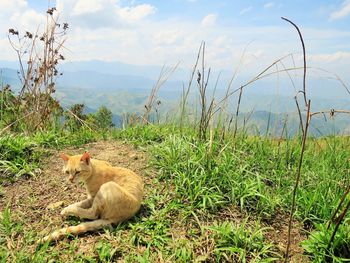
[0,141,307,262]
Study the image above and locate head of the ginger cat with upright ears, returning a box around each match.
[60,152,92,182]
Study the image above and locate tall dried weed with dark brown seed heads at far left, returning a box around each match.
[8,8,68,132]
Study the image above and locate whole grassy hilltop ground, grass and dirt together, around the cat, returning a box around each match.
[0,126,350,262]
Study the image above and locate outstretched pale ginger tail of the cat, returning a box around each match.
[37,219,113,244]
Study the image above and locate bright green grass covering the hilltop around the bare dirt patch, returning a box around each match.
[0,125,350,262]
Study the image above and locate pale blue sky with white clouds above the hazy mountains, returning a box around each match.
[0,0,350,85]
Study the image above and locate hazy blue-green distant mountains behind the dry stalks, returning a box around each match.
[0,61,350,136]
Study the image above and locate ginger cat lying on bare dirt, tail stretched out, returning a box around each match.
[39,152,143,243]
